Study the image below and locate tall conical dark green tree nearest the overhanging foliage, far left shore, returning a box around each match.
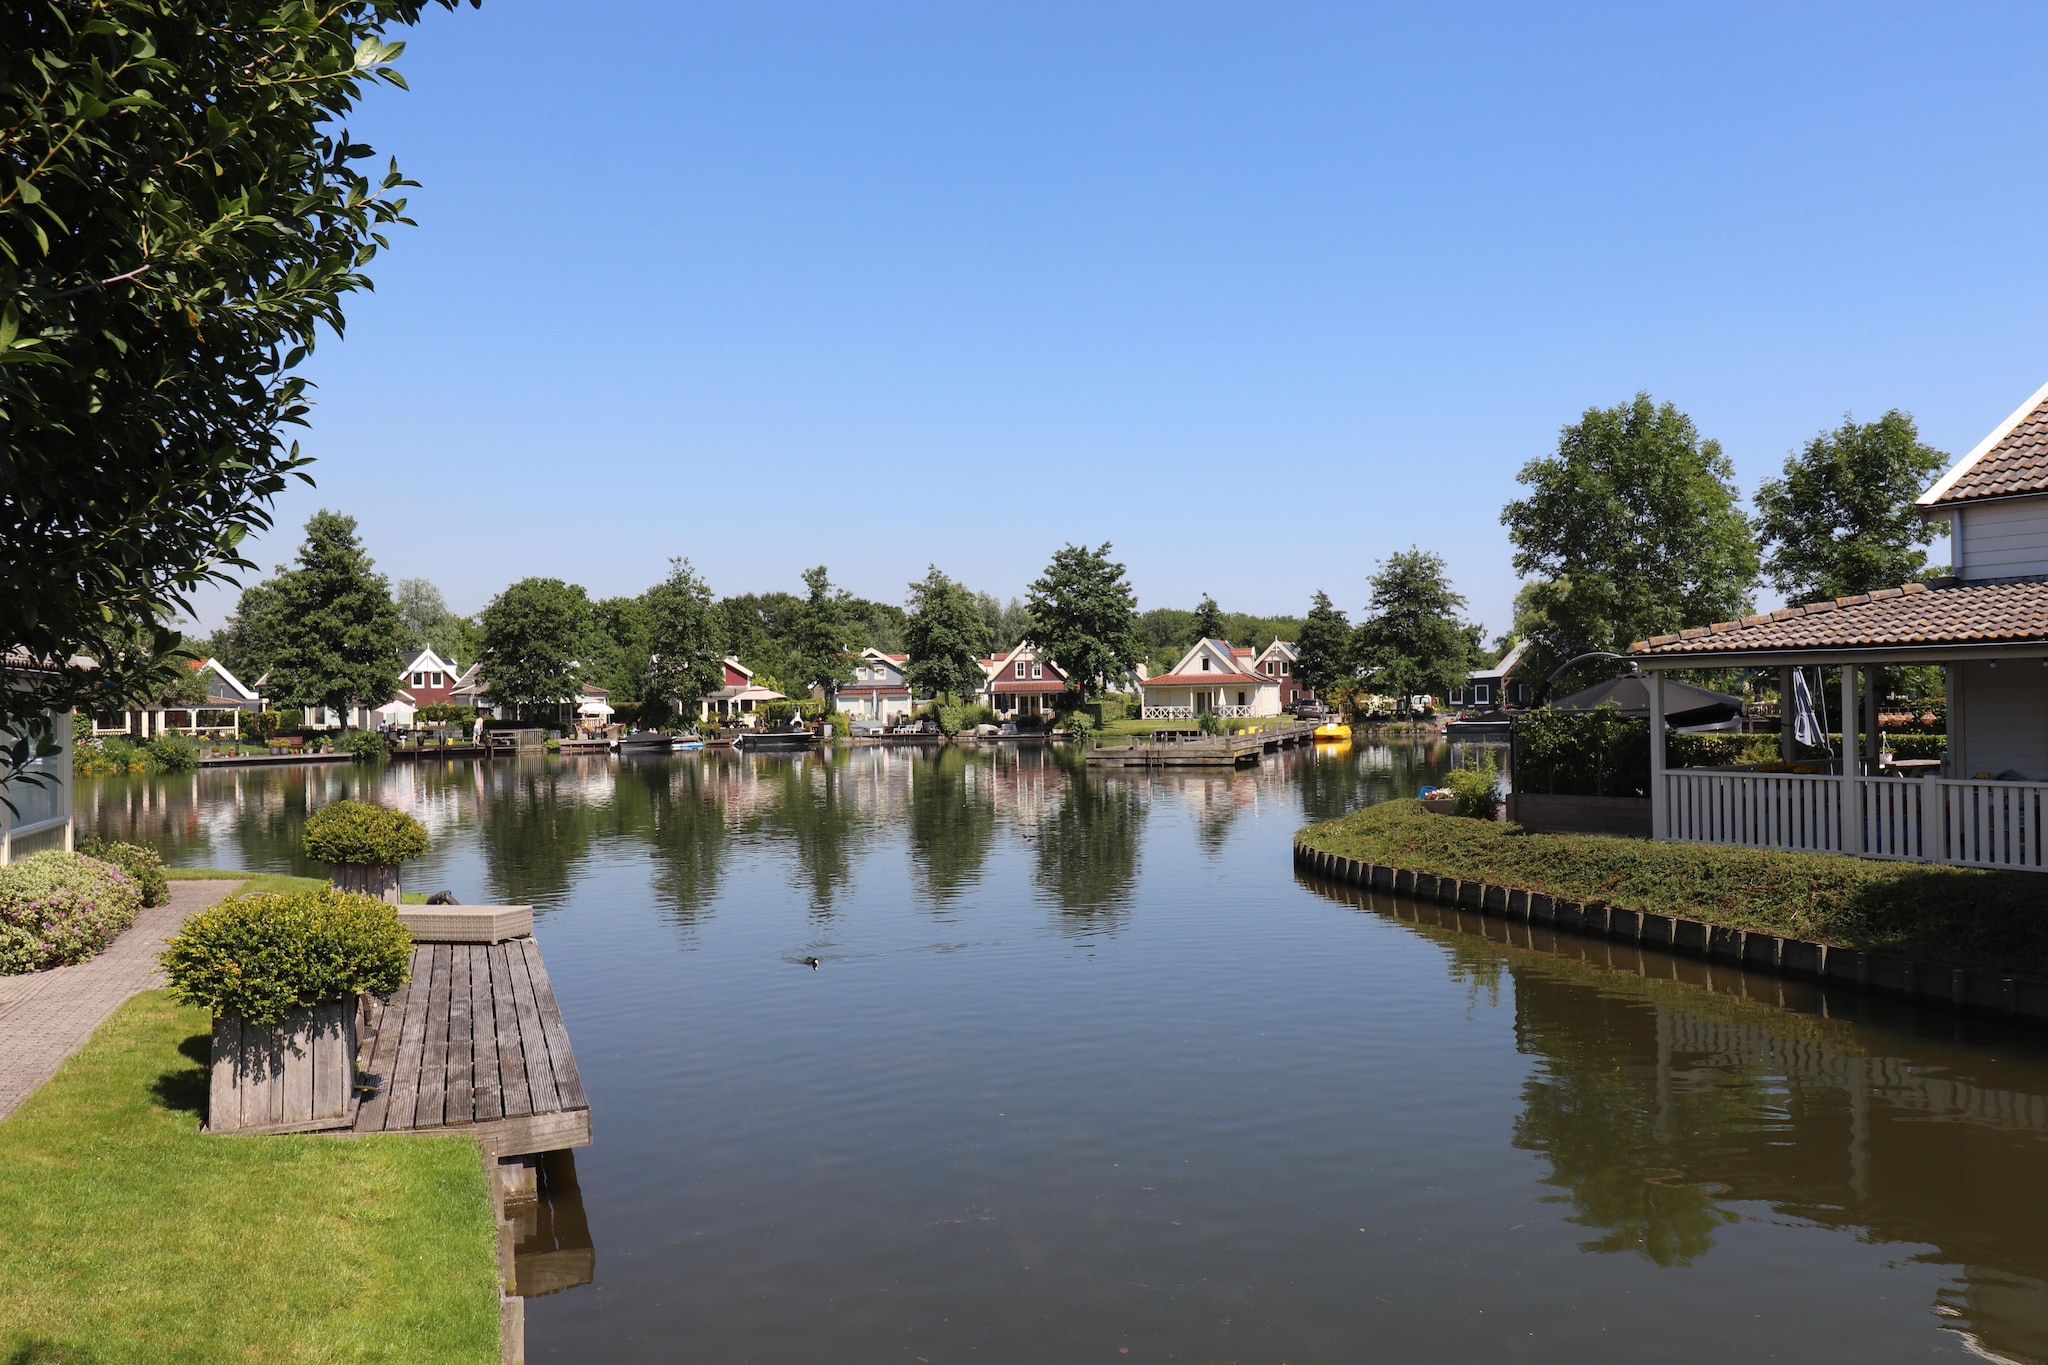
[262,510,406,710]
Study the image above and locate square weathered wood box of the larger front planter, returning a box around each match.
[207,999,356,1134]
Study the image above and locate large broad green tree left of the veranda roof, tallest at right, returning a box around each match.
[1501,393,1757,667]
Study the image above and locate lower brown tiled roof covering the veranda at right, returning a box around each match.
[1628,579,2048,659]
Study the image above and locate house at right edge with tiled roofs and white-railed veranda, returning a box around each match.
[1628,385,2048,872]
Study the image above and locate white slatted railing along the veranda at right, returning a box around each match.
[1659,767,2048,872]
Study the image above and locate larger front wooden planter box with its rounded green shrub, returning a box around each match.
[158,886,412,1132]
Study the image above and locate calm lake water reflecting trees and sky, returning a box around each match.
[80,747,2048,1365]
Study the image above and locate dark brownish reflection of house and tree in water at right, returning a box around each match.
[1305,882,2048,1365]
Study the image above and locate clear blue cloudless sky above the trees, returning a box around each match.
[201,0,2048,632]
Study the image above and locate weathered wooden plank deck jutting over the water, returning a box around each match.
[352,935,590,1158]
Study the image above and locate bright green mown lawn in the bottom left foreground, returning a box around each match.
[0,990,498,1365]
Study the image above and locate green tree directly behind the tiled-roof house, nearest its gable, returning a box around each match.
[1755,407,1950,604]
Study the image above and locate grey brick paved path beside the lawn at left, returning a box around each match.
[0,882,242,1119]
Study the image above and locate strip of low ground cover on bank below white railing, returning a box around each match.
[1300,800,2048,976]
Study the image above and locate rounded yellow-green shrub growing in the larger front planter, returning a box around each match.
[158,888,412,1023]
